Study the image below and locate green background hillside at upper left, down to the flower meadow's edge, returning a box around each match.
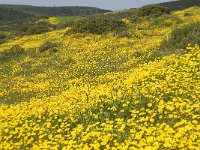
[0,5,110,44]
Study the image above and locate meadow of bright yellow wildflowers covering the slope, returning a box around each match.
[0,7,200,150]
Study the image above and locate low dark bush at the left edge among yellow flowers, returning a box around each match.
[0,45,25,61]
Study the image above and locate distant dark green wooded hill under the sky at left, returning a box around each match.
[0,5,109,20]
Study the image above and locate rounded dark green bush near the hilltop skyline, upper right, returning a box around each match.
[135,5,170,17]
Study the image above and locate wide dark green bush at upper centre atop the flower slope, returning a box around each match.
[70,18,126,34]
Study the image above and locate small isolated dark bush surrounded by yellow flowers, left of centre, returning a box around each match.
[39,41,59,53]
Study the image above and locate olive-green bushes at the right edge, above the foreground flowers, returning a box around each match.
[153,22,200,57]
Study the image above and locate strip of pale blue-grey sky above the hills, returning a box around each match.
[0,0,176,10]
